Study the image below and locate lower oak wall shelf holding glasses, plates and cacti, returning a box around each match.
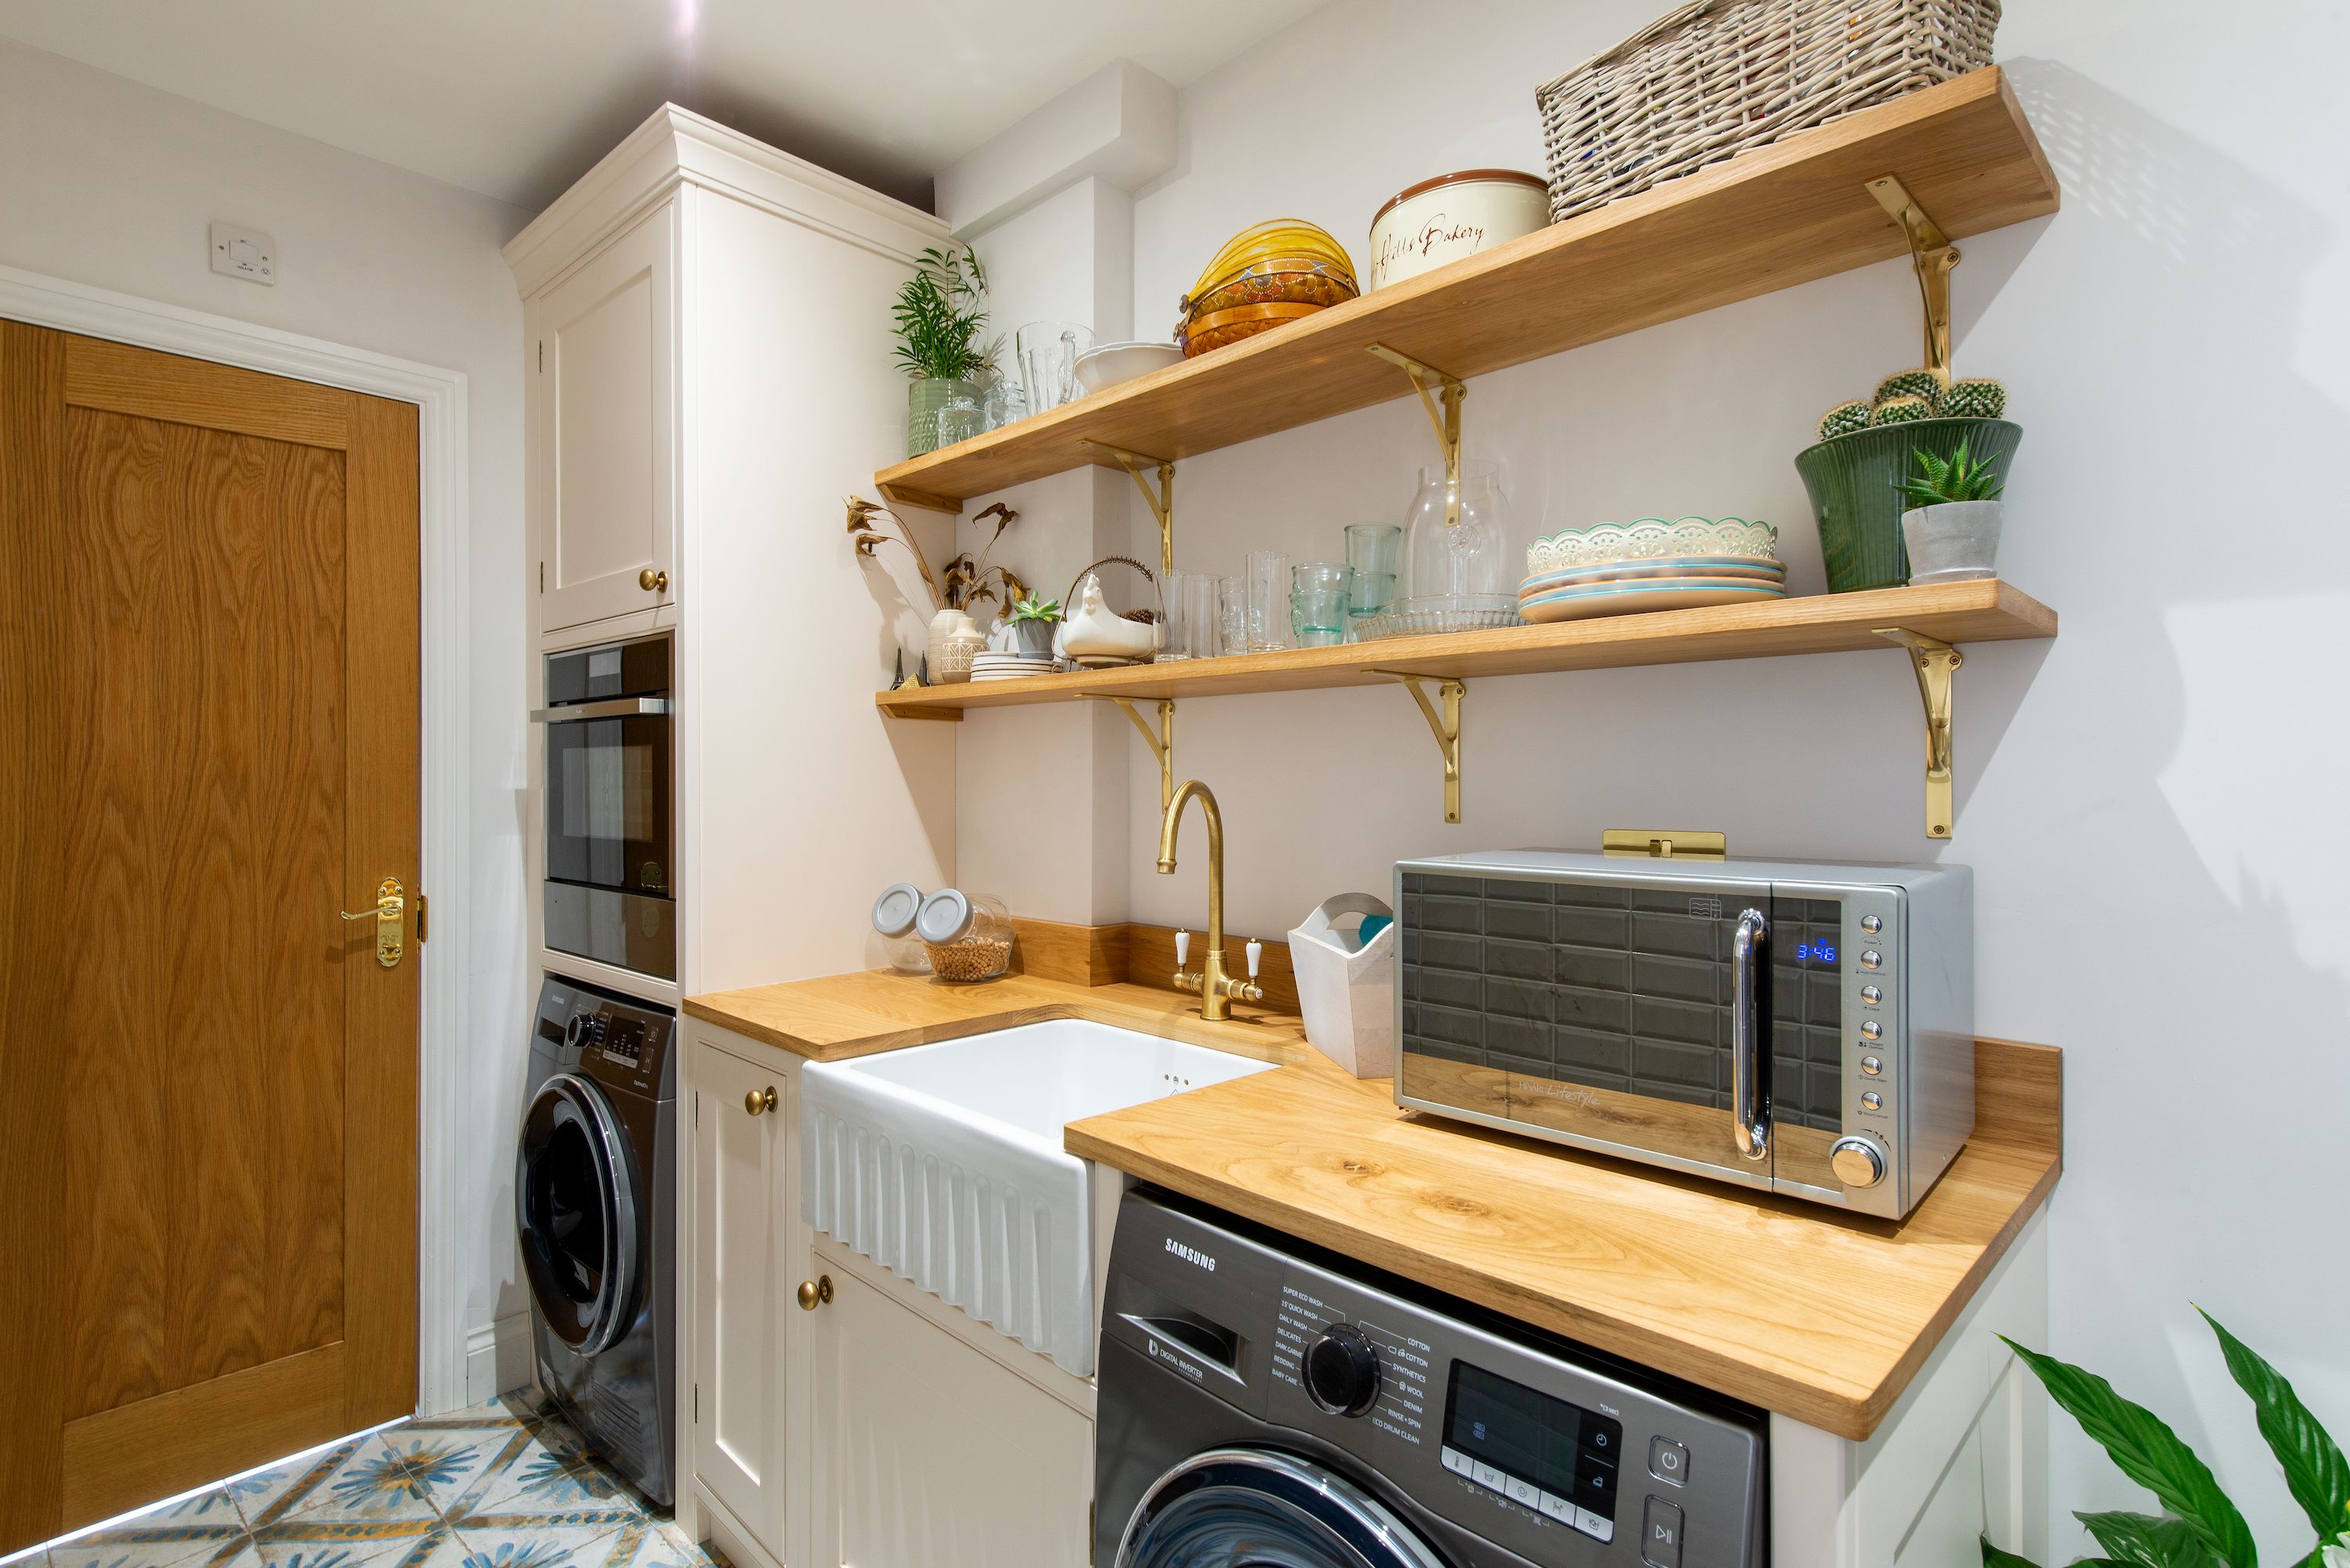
[874,578,2056,719]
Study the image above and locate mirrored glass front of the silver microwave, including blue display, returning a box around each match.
[1398,873,1842,1183]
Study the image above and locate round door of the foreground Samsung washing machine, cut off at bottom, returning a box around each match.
[1119,1448,1448,1568]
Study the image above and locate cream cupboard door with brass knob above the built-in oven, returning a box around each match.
[531,202,677,630]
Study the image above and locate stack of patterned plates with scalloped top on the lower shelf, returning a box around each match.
[1518,517,1786,623]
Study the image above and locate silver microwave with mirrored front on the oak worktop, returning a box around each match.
[1396,851,1974,1218]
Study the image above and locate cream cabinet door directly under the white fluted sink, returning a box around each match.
[811,1270,1093,1568]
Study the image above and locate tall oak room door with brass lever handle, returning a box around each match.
[0,322,418,1552]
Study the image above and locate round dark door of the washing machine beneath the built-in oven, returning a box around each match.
[515,1072,637,1357]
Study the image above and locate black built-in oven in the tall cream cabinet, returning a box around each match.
[531,637,677,981]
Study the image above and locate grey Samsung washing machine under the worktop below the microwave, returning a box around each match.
[1093,1187,1770,1568]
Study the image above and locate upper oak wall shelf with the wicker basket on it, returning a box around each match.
[874,66,2059,512]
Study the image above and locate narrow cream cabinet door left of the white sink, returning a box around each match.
[693,1042,797,1556]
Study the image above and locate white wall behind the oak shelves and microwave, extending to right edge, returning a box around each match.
[964,0,2350,1561]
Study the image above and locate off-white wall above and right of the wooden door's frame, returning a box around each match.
[0,40,529,1378]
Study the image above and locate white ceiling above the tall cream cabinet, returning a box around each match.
[0,0,1321,211]
